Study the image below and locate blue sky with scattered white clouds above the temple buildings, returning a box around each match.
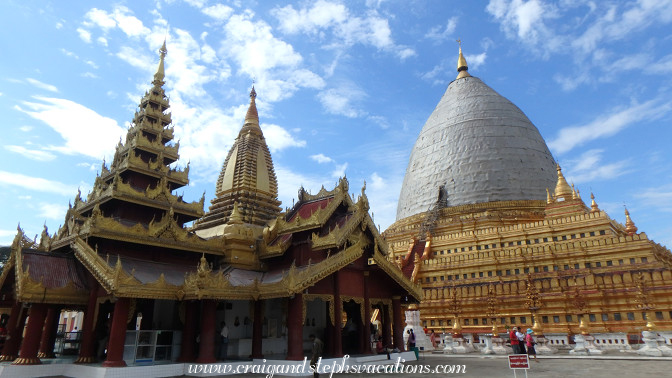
[0,0,672,246]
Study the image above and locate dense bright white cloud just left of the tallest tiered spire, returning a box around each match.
[18,96,126,159]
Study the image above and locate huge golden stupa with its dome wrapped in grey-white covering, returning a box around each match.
[383,48,672,340]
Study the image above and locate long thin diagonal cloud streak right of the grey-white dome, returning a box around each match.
[548,99,672,154]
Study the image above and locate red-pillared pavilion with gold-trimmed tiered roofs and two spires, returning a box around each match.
[0,42,422,367]
